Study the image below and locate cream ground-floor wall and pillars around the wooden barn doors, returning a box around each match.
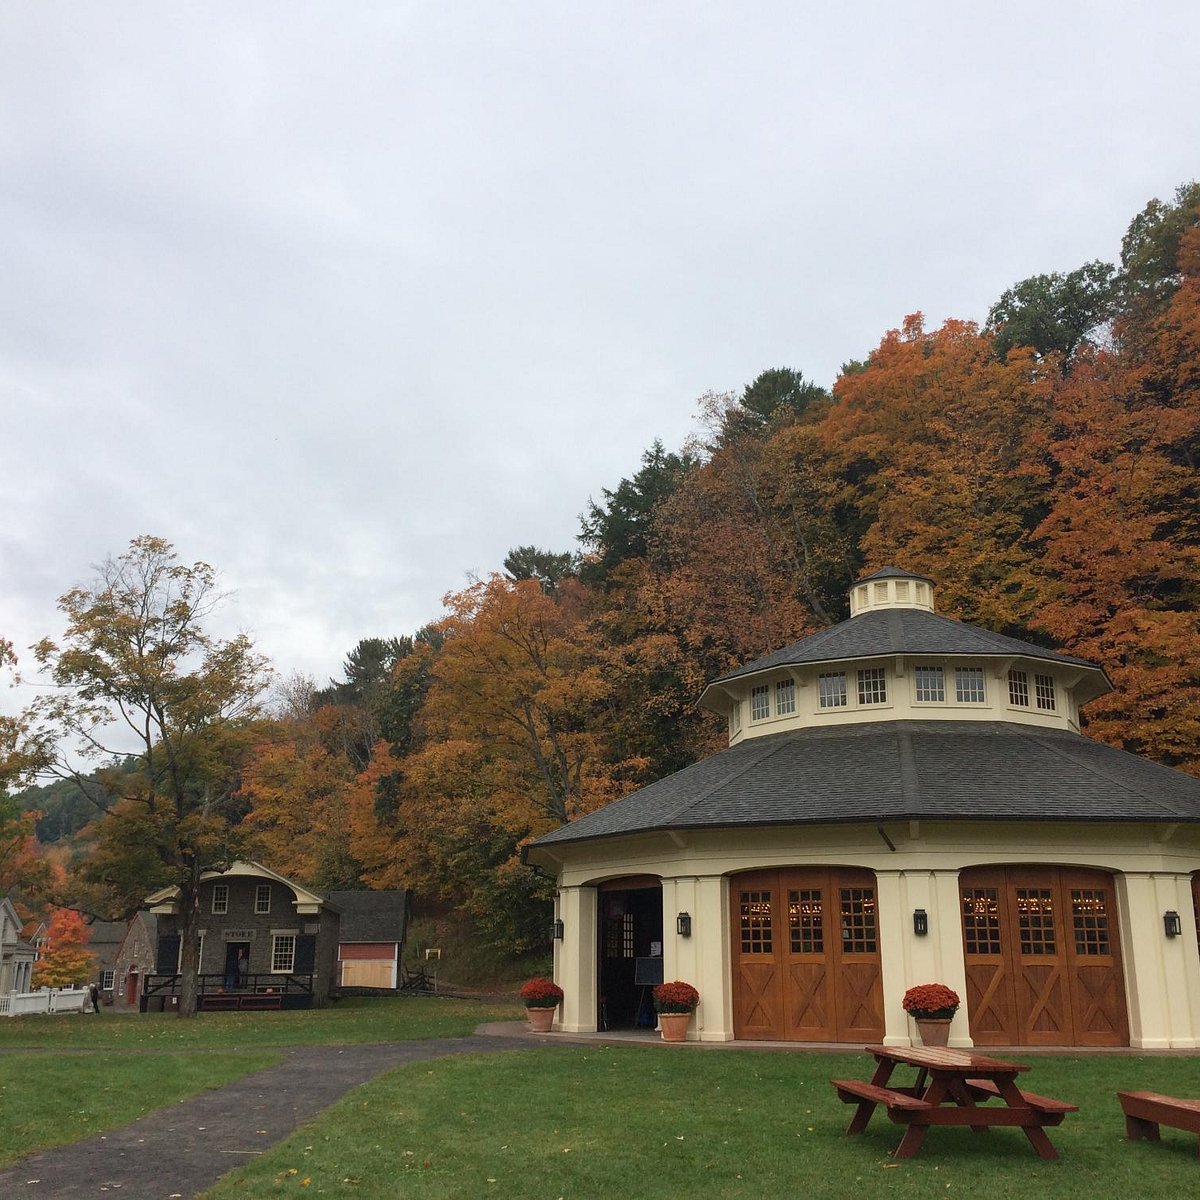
[538,822,1200,1049]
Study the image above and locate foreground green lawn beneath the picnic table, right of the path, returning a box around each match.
[206,1046,1200,1200]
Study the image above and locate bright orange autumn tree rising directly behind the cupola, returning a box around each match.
[821,313,1058,632]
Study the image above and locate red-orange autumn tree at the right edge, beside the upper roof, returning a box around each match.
[1038,227,1200,773]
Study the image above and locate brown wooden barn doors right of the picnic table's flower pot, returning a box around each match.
[960,866,1129,1046]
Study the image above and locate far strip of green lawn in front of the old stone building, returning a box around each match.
[0,996,523,1050]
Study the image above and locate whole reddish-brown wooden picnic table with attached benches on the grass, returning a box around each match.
[829,1046,1079,1159]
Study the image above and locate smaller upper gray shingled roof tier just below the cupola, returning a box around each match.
[713,608,1111,694]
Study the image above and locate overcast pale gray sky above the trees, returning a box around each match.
[0,0,1200,703]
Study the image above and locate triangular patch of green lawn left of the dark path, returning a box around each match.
[0,1056,282,1166]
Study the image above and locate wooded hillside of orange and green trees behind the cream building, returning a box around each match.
[9,184,1200,949]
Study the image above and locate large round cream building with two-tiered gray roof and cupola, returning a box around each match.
[526,568,1200,1049]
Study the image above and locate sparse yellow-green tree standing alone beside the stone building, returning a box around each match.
[35,536,268,1016]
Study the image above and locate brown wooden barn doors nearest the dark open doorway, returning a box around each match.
[730,868,883,1042]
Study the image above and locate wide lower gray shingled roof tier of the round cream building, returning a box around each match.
[533,721,1200,848]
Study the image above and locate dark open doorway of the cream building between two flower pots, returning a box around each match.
[600,877,662,1030]
